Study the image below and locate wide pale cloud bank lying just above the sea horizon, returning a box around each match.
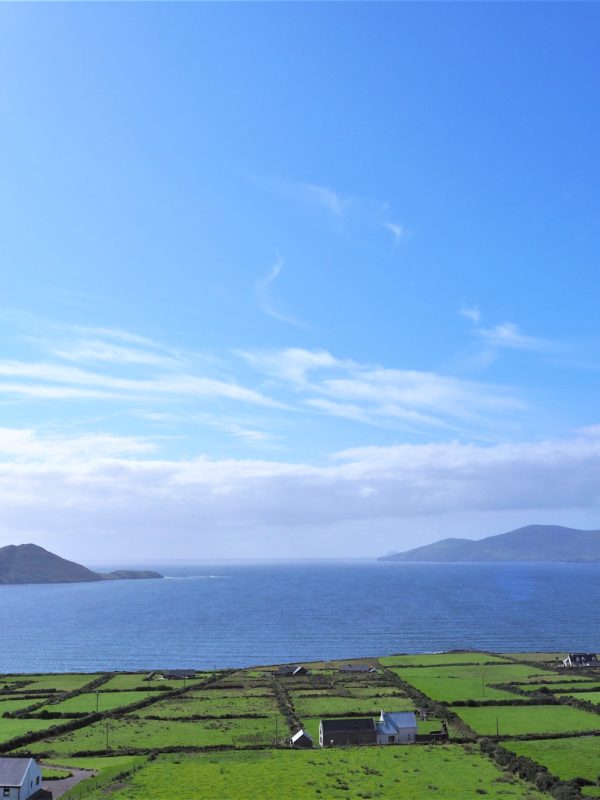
[0,430,600,557]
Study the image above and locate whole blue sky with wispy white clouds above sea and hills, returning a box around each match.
[0,3,600,560]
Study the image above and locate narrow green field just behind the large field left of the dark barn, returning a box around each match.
[134,689,277,718]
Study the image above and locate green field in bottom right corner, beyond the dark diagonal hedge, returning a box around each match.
[502,736,600,781]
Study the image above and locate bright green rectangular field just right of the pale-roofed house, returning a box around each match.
[455,706,600,736]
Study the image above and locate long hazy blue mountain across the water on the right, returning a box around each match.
[378,525,600,563]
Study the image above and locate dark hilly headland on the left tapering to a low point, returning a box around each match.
[0,544,163,584]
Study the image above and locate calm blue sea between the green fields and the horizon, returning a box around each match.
[0,562,600,672]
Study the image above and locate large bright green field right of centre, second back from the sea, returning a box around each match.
[391,664,551,702]
